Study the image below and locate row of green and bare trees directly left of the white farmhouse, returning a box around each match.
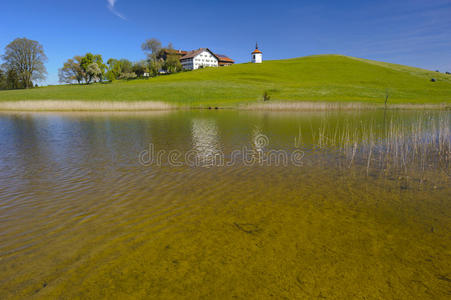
[59,38,182,84]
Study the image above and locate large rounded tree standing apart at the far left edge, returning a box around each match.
[0,38,47,90]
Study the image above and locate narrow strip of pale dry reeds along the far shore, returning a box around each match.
[0,100,451,112]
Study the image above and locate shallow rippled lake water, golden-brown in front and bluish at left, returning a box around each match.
[0,111,451,299]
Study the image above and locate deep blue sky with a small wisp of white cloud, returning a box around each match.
[0,0,451,84]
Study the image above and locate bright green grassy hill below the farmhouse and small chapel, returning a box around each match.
[0,55,451,106]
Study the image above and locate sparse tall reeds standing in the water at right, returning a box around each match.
[298,112,451,183]
